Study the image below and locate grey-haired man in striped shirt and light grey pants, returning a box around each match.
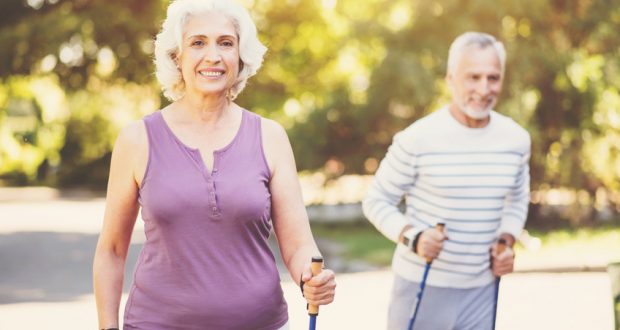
[363,32,530,330]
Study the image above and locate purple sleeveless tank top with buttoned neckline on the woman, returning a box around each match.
[124,110,288,330]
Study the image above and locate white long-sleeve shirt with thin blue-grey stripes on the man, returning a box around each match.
[363,107,531,288]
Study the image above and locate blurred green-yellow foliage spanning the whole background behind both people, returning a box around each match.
[0,0,620,222]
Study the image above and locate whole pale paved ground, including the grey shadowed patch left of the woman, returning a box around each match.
[0,188,614,330]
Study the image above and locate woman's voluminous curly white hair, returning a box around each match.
[155,0,267,101]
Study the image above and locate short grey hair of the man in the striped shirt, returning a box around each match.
[448,32,506,76]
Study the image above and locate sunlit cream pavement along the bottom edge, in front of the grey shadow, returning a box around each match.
[0,270,613,330]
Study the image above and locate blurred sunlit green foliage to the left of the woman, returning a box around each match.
[0,0,165,187]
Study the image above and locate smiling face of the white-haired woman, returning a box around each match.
[178,12,239,96]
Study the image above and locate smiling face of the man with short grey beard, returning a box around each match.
[447,46,503,120]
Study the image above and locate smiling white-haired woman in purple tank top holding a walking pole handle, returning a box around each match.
[93,0,336,330]
